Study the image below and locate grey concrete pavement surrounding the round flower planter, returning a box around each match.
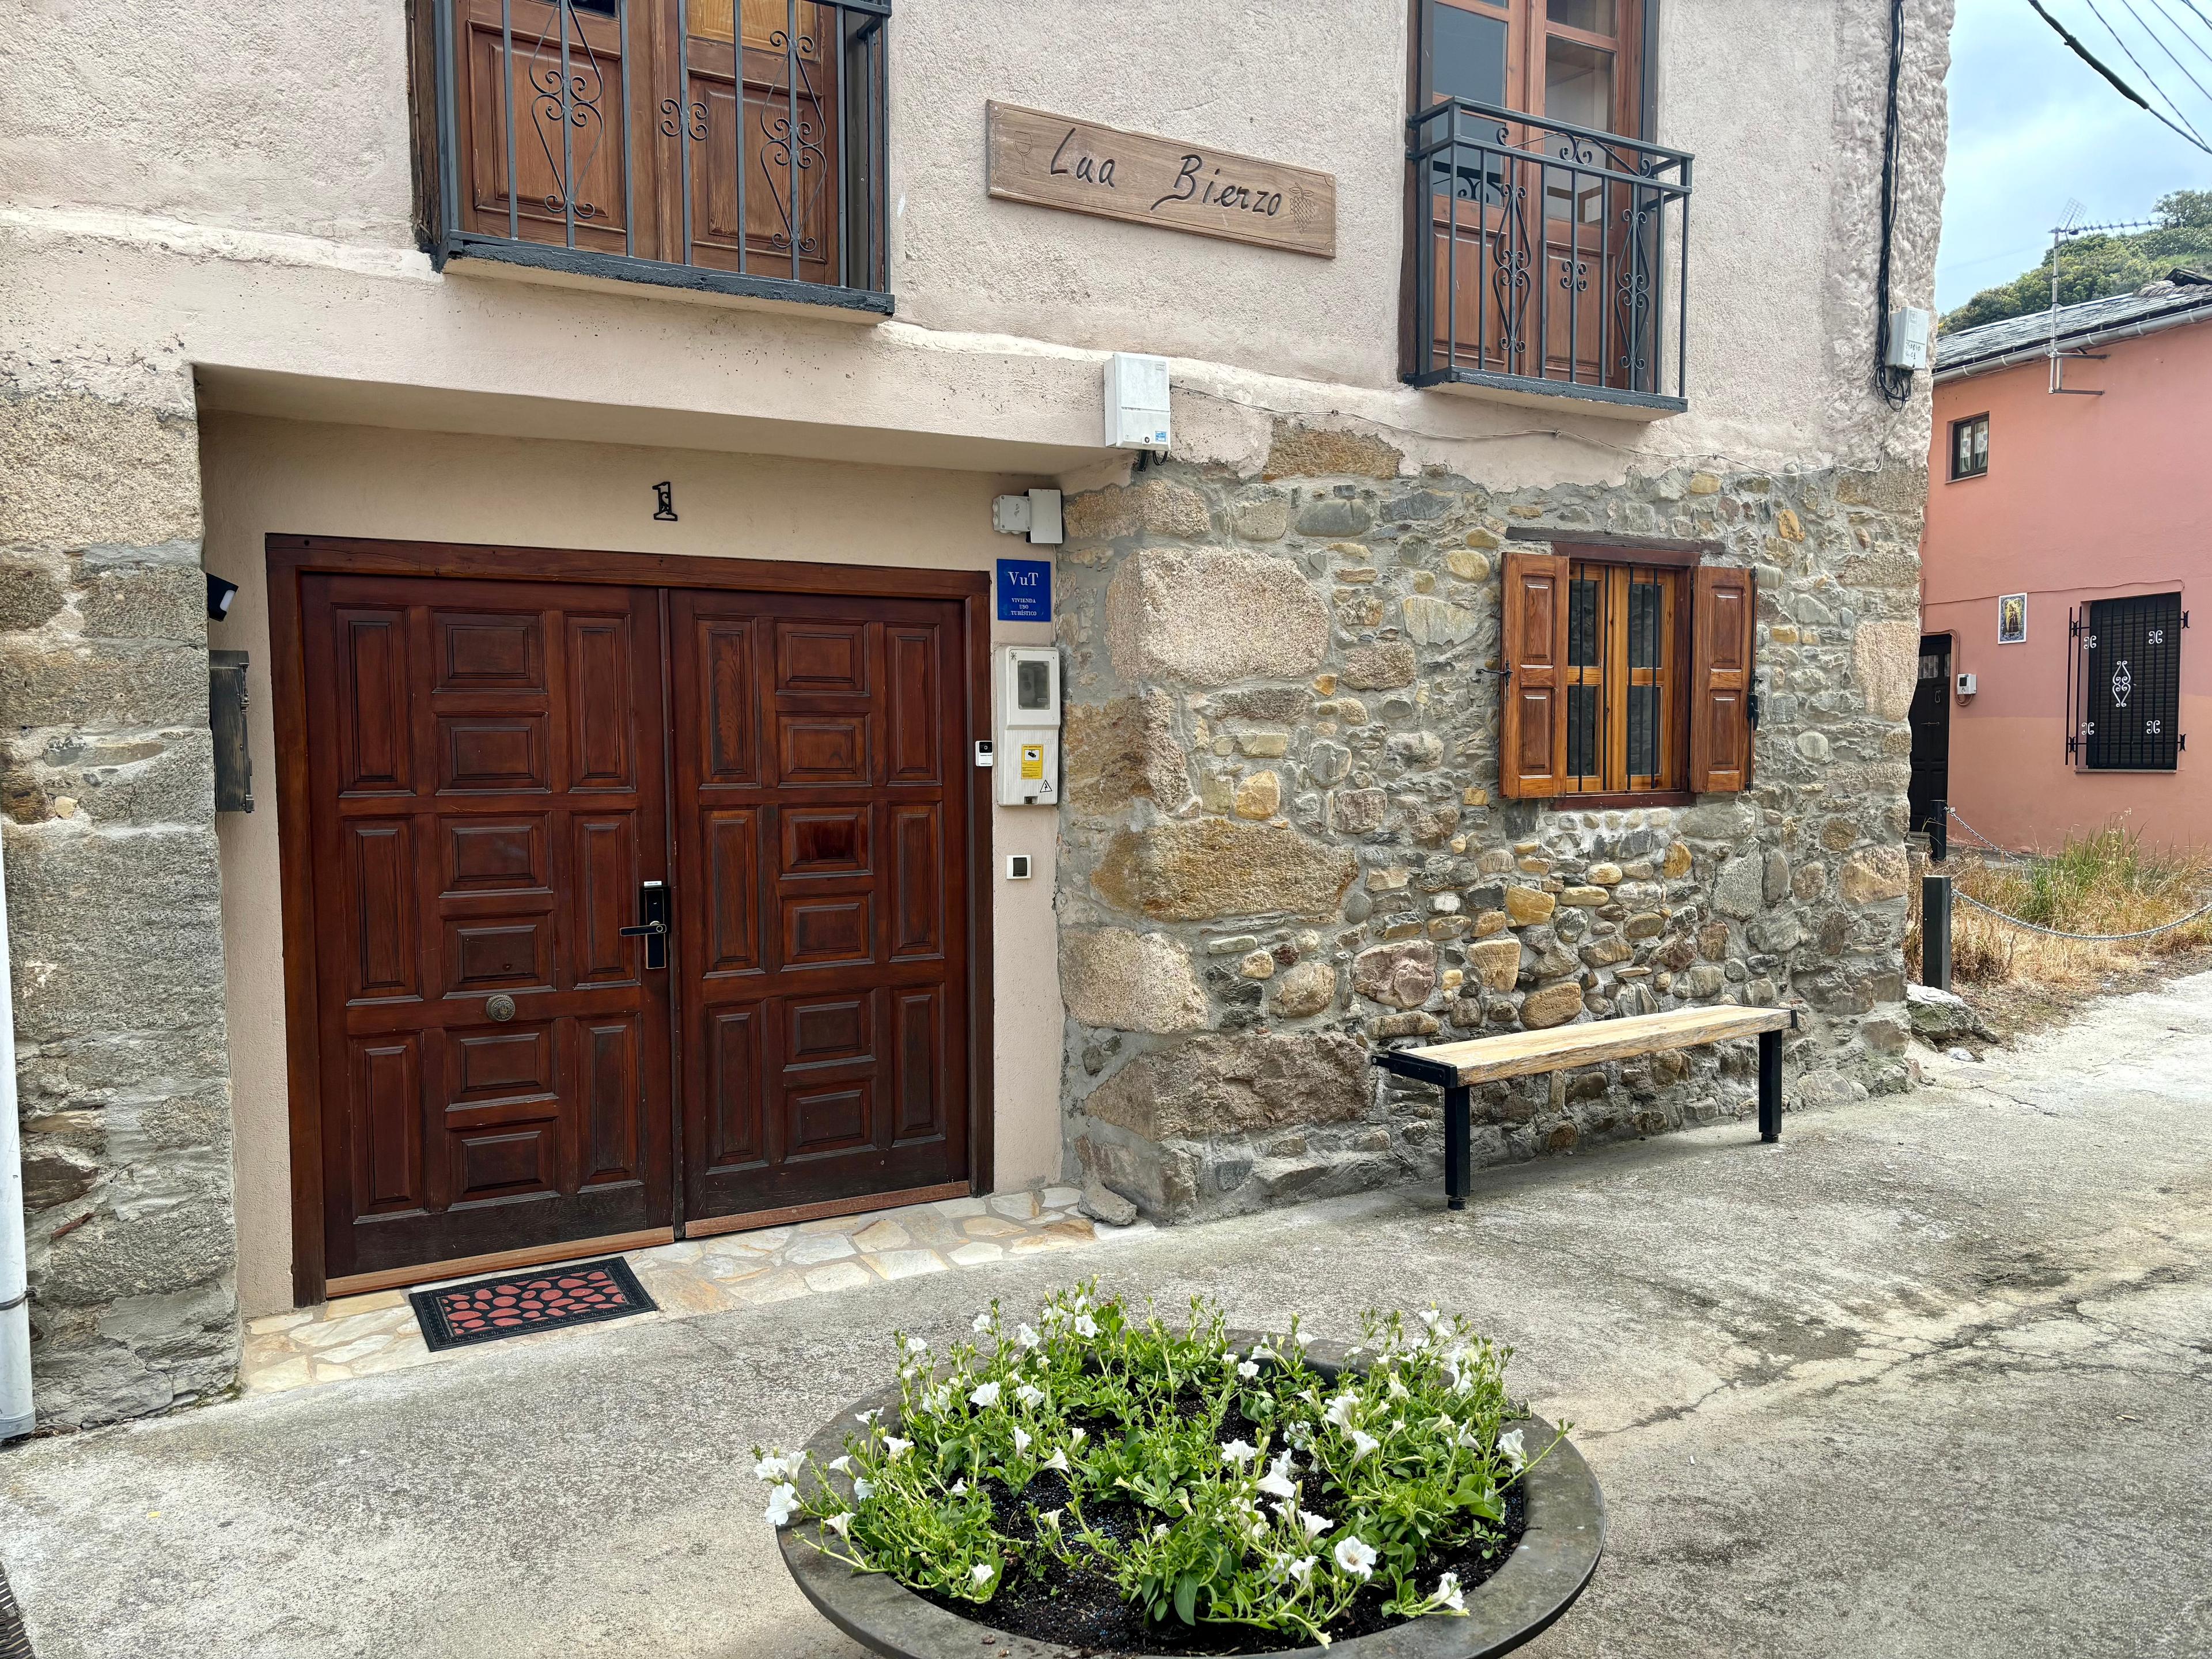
[0,975,2212,1659]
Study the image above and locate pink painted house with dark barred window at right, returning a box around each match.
[1911,272,2212,847]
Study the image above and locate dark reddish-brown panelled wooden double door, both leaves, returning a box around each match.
[298,573,974,1290]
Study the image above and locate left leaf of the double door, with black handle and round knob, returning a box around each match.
[301,575,672,1279]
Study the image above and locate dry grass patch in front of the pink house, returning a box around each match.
[1904,825,2212,991]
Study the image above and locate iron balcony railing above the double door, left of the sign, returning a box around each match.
[427,0,892,314]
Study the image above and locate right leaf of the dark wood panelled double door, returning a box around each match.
[668,593,969,1221]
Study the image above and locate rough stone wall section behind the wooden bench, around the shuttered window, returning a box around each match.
[1059,427,1925,1219]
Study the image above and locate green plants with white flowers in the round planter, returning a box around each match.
[754,1281,1566,1643]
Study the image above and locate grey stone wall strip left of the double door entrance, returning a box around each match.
[0,373,237,1427]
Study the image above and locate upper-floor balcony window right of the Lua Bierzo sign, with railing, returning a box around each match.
[1404,0,1690,409]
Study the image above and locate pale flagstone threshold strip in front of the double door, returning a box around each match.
[239,1185,1153,1396]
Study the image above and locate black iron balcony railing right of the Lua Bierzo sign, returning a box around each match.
[1404,100,1690,409]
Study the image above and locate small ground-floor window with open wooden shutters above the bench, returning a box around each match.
[1498,553,1756,801]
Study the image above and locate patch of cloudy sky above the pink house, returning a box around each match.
[1936,0,2212,310]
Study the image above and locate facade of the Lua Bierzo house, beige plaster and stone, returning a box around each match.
[0,0,1951,1429]
